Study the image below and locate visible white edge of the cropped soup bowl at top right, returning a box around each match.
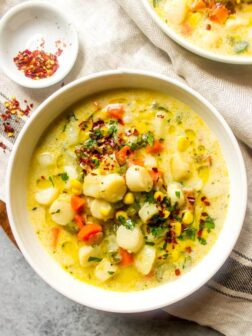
[141,0,252,64]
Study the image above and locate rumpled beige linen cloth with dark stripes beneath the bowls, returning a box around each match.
[0,0,252,336]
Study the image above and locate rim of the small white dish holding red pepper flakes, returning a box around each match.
[0,0,79,89]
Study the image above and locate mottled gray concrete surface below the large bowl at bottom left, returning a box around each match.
[0,229,220,336]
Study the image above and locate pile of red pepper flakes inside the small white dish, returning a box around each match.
[13,49,59,80]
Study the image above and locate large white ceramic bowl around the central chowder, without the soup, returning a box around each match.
[7,70,247,313]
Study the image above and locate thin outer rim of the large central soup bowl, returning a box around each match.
[6,70,247,313]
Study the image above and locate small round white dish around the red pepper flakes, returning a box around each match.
[0,1,78,88]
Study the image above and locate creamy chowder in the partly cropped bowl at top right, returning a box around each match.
[150,0,252,56]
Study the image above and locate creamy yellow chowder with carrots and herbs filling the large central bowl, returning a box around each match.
[28,89,229,291]
